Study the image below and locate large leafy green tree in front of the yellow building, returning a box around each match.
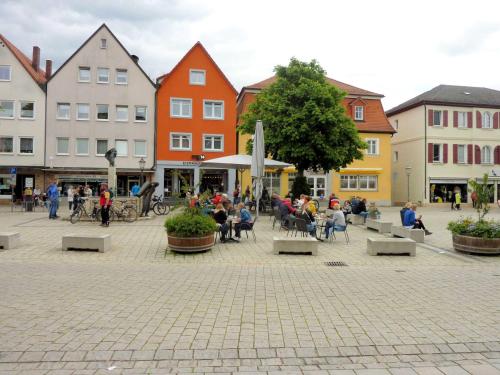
[238,58,366,176]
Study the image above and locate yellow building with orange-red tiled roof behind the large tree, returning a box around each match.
[237,77,395,206]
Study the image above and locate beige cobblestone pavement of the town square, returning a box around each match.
[0,207,500,375]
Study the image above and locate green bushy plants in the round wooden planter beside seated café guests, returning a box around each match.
[165,208,217,237]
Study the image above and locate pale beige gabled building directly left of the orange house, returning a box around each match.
[45,24,155,195]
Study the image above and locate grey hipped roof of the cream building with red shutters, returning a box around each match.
[386,85,500,116]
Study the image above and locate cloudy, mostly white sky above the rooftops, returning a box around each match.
[0,0,500,109]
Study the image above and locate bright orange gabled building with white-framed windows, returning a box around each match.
[156,42,238,195]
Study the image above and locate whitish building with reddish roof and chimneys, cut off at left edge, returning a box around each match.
[0,34,52,200]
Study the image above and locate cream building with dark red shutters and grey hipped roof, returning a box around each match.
[387,85,500,203]
